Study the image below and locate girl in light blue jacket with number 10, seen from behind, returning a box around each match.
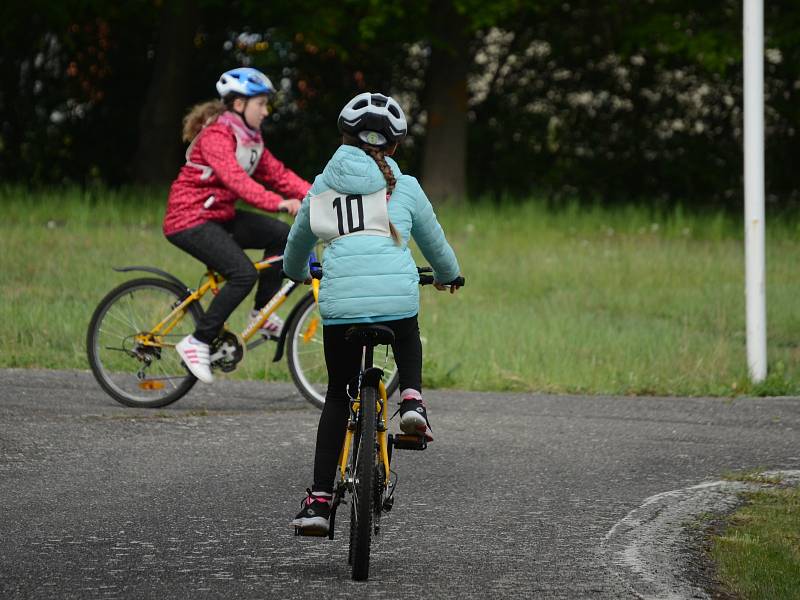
[284,92,459,533]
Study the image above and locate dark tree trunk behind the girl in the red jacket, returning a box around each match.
[132,0,200,185]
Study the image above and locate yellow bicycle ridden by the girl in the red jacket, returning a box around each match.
[86,256,399,408]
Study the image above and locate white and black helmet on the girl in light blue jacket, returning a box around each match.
[337,92,408,147]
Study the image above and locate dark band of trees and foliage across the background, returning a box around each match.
[0,0,800,209]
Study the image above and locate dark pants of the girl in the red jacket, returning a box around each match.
[167,210,289,344]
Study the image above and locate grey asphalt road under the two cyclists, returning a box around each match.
[0,370,800,599]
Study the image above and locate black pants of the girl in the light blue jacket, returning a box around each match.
[313,316,422,492]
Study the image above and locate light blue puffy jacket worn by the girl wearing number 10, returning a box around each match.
[283,146,460,325]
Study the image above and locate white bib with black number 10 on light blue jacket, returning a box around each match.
[309,188,392,244]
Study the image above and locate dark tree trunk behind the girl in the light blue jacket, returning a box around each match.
[422,2,470,202]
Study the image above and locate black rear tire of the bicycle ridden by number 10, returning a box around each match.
[350,386,378,581]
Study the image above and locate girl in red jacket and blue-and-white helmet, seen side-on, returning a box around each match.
[163,67,311,383]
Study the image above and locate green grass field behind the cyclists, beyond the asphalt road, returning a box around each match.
[0,188,800,396]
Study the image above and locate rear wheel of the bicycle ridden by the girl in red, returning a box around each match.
[86,278,203,408]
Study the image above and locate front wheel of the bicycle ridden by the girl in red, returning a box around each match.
[286,292,400,408]
